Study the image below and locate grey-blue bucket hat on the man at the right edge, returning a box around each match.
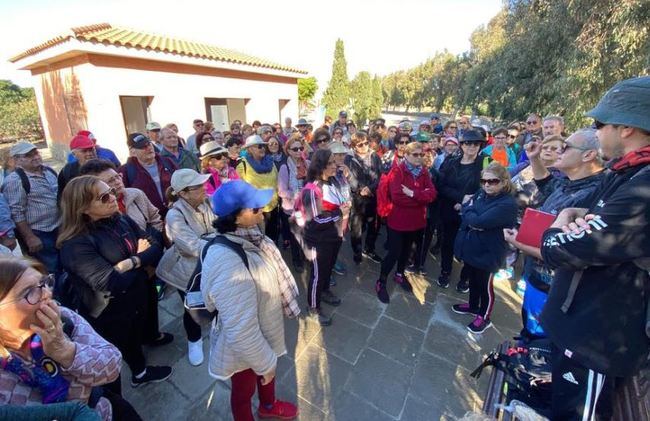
[585,76,650,131]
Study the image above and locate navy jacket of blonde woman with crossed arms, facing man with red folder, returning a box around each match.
[454,190,517,272]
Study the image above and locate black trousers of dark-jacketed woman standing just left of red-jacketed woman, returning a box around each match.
[350,196,379,256]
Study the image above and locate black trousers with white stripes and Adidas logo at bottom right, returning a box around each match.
[551,346,615,420]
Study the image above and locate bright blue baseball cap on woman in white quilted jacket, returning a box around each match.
[212,180,273,218]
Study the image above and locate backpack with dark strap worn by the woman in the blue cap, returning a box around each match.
[184,235,250,325]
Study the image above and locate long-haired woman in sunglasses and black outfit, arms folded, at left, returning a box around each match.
[57,175,172,394]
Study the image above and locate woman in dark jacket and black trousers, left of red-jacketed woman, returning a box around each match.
[345,132,381,263]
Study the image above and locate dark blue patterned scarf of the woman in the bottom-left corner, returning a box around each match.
[0,335,70,404]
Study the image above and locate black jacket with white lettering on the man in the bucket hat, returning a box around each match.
[541,162,650,377]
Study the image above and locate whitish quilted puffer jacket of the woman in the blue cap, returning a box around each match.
[201,234,286,380]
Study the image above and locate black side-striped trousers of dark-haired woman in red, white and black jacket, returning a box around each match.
[307,238,343,308]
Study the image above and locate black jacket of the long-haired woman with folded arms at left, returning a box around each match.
[61,215,163,316]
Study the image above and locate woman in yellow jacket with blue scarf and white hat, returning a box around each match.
[237,135,280,242]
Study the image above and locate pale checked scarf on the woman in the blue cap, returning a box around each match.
[233,227,300,318]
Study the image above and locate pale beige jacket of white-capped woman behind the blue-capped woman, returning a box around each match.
[156,199,216,291]
